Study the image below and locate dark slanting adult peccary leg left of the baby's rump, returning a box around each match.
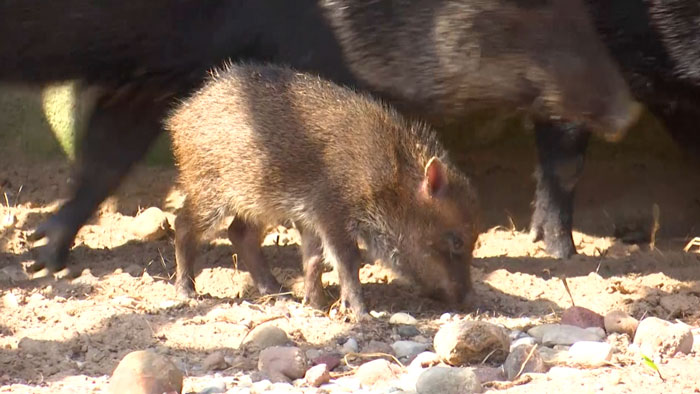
[30,87,169,272]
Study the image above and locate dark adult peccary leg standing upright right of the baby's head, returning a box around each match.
[530,123,590,258]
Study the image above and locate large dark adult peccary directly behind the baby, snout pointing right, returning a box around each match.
[0,0,636,276]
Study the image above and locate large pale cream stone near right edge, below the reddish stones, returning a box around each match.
[633,317,693,358]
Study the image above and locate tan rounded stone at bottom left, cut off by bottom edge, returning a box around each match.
[108,350,182,394]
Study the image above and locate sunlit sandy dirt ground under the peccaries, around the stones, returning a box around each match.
[0,124,700,393]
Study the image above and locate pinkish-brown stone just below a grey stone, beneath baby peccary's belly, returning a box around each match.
[258,346,308,383]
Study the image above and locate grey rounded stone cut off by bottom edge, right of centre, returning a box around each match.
[416,366,482,394]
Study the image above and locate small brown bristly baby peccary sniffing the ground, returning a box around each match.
[166,64,477,317]
